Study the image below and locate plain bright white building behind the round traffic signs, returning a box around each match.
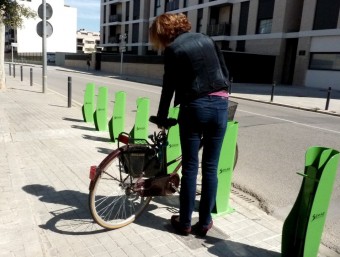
[12,0,77,54]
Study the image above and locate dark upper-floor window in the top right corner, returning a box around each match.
[313,0,340,30]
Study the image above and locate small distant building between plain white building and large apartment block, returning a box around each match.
[77,29,101,54]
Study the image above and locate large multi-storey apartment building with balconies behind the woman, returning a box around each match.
[100,0,340,89]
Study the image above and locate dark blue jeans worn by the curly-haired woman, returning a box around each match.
[178,96,228,228]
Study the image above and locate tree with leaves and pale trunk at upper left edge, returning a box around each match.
[0,0,36,90]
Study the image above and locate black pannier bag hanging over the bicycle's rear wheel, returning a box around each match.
[122,145,161,177]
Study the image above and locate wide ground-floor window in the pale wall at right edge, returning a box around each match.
[309,53,340,71]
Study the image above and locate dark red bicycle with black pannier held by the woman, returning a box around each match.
[89,101,238,229]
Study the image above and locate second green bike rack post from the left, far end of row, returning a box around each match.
[94,87,108,131]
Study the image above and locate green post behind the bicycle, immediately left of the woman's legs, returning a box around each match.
[166,107,182,176]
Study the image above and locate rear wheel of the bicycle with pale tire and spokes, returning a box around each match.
[89,148,152,229]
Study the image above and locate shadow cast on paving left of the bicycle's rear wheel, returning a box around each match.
[23,184,108,235]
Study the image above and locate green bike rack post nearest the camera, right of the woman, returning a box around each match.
[281,147,340,257]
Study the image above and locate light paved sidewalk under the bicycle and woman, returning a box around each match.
[0,76,340,257]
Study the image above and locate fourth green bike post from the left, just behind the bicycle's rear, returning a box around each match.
[130,97,150,140]
